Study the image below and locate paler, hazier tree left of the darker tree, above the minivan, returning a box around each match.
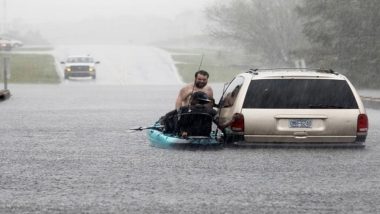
[206,0,304,66]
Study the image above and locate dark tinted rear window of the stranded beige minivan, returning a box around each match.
[243,79,358,109]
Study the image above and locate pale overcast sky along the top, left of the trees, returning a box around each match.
[0,0,214,23]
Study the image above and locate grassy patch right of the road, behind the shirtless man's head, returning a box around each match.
[166,49,254,82]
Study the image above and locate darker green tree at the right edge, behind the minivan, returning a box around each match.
[297,0,380,87]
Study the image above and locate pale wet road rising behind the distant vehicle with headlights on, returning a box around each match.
[53,45,182,85]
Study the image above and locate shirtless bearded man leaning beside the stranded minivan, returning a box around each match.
[175,70,214,109]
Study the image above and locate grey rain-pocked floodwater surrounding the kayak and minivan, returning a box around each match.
[0,84,380,213]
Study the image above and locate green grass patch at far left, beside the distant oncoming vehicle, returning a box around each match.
[0,54,60,84]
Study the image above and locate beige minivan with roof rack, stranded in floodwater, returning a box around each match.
[219,69,368,147]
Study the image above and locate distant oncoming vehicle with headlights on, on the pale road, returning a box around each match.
[61,55,100,79]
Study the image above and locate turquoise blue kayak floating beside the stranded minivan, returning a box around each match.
[147,122,222,148]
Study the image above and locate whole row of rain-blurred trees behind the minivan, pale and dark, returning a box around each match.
[206,0,380,88]
